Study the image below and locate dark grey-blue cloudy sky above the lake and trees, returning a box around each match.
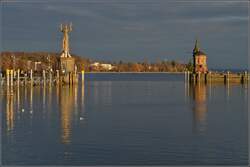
[0,0,249,69]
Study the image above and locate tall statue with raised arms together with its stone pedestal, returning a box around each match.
[60,24,77,84]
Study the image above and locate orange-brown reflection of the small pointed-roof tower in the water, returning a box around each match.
[192,84,207,131]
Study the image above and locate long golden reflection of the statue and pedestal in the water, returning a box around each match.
[60,86,74,144]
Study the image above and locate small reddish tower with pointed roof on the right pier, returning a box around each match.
[193,40,208,73]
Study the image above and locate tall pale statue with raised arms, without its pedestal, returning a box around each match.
[60,23,72,57]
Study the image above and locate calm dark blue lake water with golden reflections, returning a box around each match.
[0,74,249,165]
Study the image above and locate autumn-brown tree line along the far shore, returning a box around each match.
[0,51,192,72]
